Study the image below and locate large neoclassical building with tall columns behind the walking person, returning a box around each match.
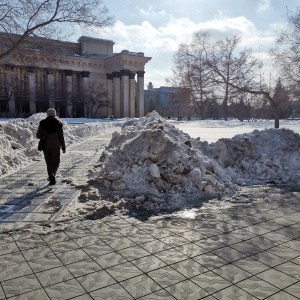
[0,34,151,117]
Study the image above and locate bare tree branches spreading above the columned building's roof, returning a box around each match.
[0,0,114,61]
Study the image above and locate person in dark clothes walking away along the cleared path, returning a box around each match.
[36,108,66,185]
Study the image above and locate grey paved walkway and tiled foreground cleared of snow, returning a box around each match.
[0,130,300,300]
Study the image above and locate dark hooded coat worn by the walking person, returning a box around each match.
[36,117,66,151]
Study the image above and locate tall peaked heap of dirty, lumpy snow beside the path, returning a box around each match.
[84,112,236,213]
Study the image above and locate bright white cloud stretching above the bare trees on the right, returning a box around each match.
[97,12,274,86]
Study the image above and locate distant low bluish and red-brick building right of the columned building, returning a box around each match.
[145,82,191,117]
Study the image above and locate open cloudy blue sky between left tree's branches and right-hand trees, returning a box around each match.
[82,0,300,87]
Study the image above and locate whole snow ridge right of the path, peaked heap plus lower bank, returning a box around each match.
[79,111,300,214]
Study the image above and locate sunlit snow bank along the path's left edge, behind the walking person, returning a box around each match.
[0,113,115,176]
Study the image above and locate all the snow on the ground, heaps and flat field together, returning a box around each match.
[0,112,300,218]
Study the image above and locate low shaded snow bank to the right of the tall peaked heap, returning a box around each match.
[204,128,300,185]
